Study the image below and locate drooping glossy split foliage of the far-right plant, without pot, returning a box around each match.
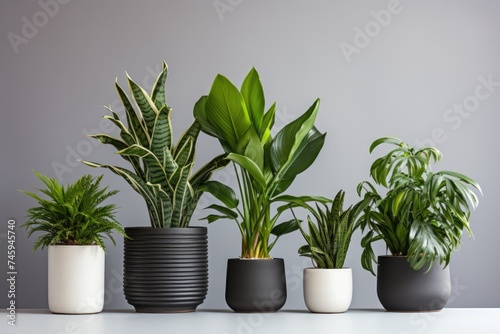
[358,137,481,275]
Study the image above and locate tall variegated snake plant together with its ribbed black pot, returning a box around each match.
[84,62,228,312]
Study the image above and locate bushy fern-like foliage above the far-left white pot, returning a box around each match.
[22,171,125,251]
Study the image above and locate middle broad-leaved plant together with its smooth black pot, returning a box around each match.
[195,69,325,312]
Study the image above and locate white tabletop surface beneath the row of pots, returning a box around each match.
[0,308,500,334]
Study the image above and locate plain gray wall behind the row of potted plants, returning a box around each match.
[0,0,500,309]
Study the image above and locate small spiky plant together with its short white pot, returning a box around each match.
[291,190,368,313]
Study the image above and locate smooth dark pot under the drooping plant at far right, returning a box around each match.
[377,256,451,312]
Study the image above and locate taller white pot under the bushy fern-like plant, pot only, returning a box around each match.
[49,245,104,314]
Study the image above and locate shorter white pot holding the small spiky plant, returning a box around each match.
[304,268,352,313]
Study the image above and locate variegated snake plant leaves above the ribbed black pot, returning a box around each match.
[84,62,228,227]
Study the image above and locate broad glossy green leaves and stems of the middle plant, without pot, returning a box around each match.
[195,69,325,258]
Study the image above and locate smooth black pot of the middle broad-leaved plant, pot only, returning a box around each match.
[226,258,286,312]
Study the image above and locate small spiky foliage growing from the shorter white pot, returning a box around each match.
[291,190,368,269]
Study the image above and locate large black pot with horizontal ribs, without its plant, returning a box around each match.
[123,227,208,313]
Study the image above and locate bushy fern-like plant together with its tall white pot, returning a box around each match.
[23,171,124,314]
